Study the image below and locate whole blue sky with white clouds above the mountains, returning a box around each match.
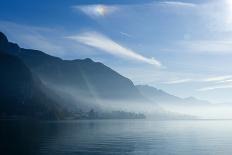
[0,0,232,103]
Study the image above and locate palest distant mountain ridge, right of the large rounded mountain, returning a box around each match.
[136,85,210,106]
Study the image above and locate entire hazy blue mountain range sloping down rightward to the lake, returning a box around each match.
[0,32,208,119]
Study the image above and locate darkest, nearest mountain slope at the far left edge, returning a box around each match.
[0,51,65,119]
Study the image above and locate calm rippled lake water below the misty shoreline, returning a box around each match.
[0,120,232,155]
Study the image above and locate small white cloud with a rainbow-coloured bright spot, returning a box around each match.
[72,4,119,17]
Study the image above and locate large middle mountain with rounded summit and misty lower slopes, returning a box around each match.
[0,33,152,117]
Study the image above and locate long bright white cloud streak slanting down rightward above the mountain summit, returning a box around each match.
[67,32,162,67]
